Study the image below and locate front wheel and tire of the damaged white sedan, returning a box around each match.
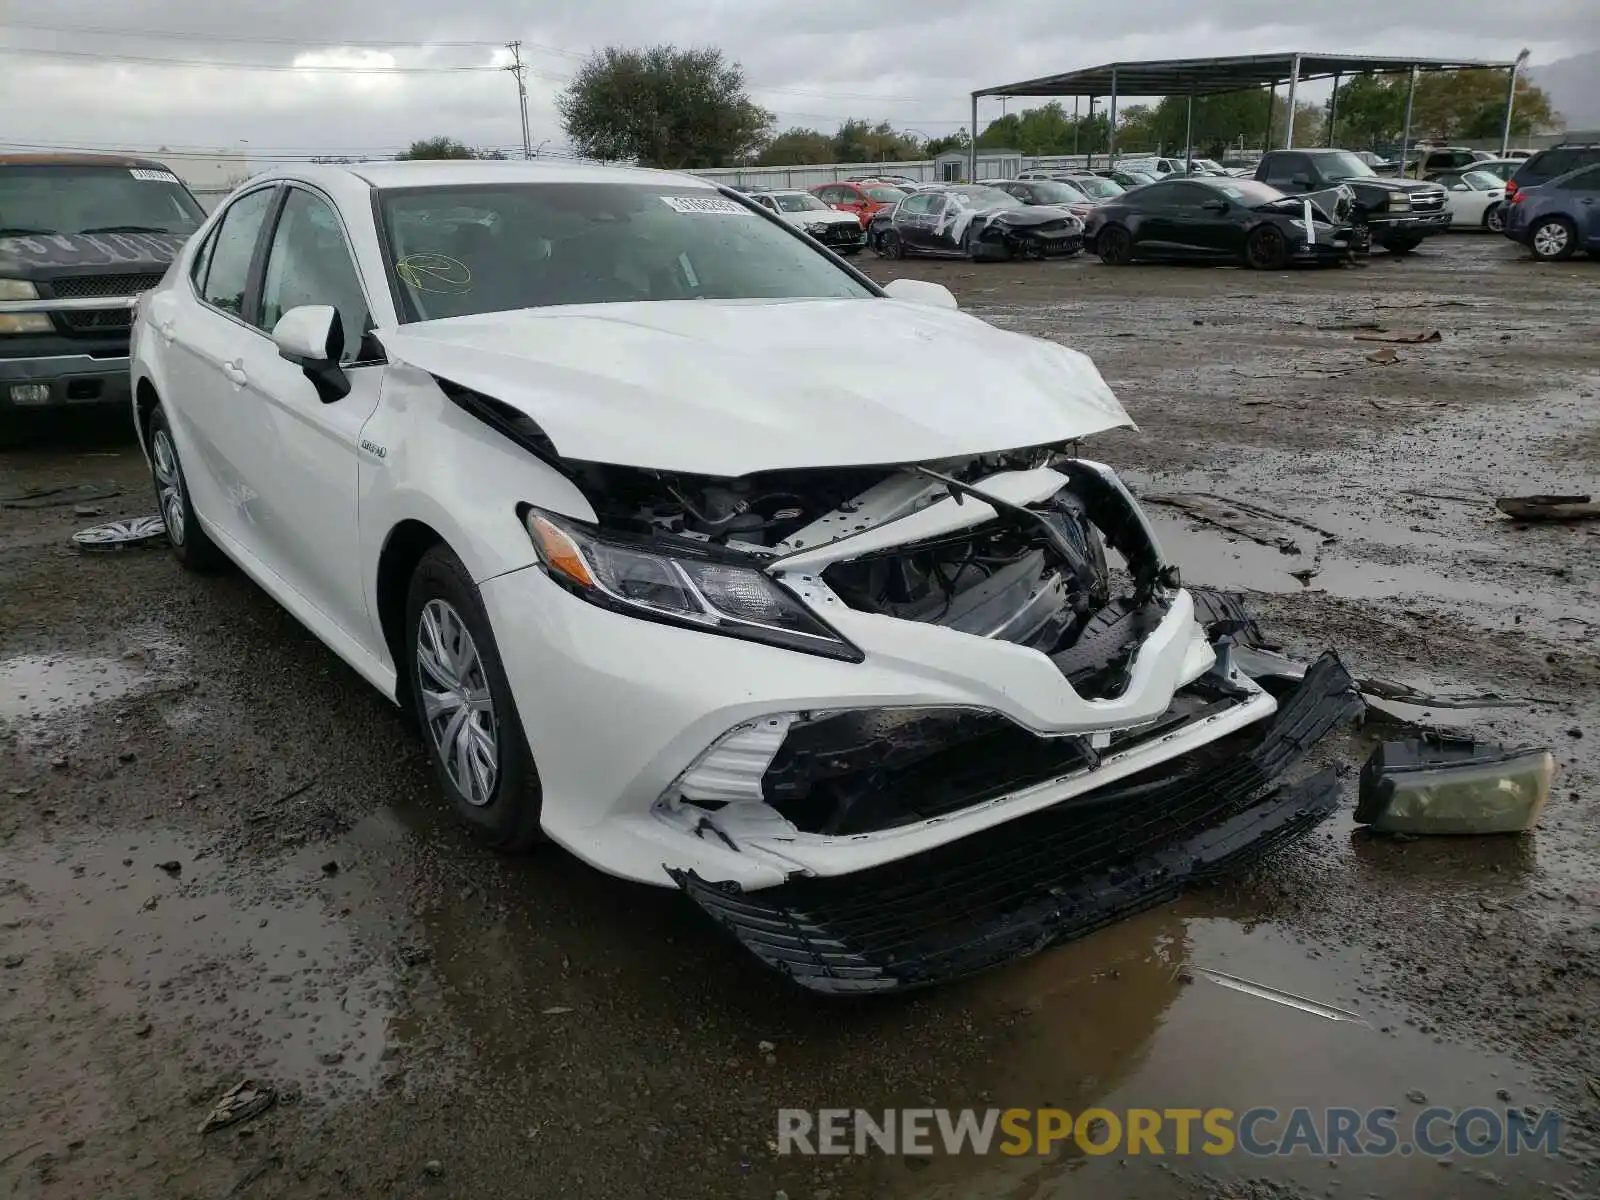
[405,546,546,853]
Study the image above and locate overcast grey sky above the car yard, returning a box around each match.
[0,0,1600,158]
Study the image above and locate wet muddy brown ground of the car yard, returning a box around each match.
[0,235,1600,1200]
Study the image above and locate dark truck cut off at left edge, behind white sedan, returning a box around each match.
[0,154,205,440]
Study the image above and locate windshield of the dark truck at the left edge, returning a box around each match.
[0,163,205,237]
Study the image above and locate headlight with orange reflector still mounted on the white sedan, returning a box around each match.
[523,509,862,662]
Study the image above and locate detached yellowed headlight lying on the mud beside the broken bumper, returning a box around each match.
[1355,731,1555,834]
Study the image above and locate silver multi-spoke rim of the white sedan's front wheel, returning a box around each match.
[416,600,499,808]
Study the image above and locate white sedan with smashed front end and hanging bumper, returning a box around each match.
[133,163,1358,992]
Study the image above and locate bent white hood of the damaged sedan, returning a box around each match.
[378,299,1133,477]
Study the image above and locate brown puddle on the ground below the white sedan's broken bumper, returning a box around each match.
[870,904,1574,1200]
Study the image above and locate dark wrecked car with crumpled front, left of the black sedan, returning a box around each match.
[867,184,1083,261]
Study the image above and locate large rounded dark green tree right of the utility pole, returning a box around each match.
[557,45,773,170]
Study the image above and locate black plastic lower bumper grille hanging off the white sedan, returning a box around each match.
[674,653,1362,994]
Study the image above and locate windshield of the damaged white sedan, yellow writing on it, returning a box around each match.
[379,182,872,320]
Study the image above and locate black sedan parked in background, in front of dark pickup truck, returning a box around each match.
[1085,178,1352,270]
